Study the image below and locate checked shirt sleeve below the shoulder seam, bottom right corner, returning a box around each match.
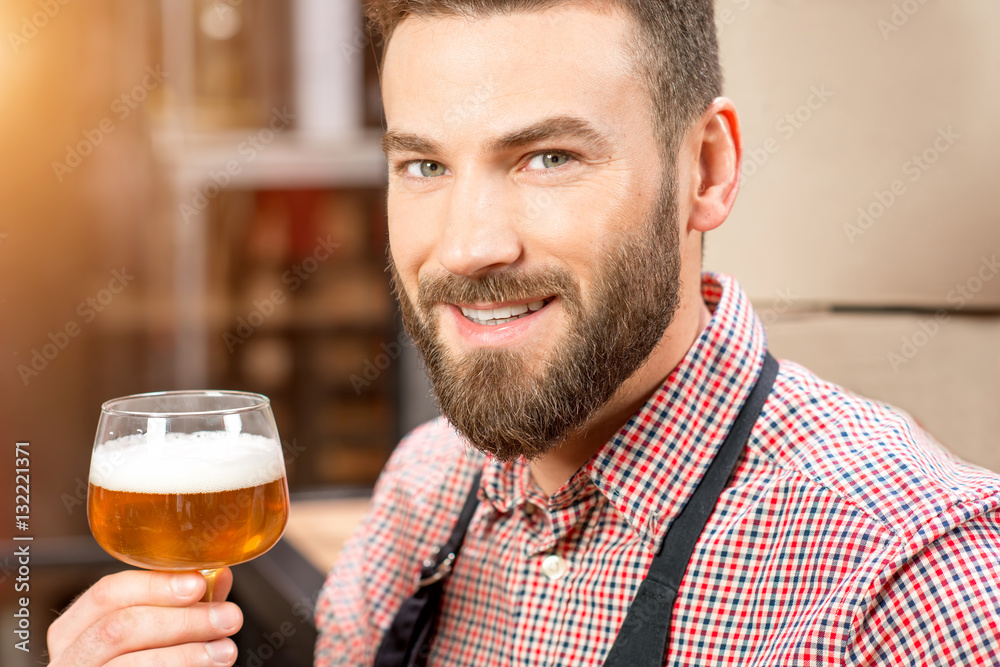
[845,511,1000,667]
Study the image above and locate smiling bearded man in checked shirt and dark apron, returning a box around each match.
[49,0,1000,666]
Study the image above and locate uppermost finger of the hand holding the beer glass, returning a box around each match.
[48,570,209,657]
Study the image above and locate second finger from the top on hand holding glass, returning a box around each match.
[54,602,243,667]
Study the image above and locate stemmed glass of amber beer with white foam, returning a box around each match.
[87,391,288,602]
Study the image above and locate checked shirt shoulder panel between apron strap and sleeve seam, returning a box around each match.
[751,361,1000,548]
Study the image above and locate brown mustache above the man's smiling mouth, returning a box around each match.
[418,267,580,310]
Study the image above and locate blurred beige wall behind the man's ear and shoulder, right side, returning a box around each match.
[706,0,1000,470]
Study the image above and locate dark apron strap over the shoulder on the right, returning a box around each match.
[604,354,778,667]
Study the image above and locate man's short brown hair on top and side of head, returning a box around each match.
[365,0,722,158]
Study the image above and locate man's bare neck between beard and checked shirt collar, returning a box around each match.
[529,290,712,496]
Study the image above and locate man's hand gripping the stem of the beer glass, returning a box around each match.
[48,568,243,667]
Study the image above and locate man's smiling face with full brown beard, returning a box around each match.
[383,5,680,460]
